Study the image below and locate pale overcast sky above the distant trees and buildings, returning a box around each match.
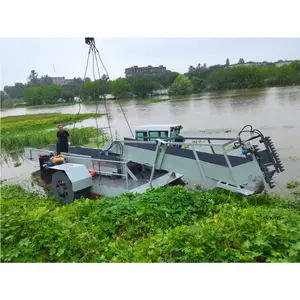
[0,38,300,89]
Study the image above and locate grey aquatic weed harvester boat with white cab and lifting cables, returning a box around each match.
[25,38,284,203]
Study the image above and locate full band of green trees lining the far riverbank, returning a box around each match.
[1,59,300,107]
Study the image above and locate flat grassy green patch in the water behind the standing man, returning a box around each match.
[0,114,106,151]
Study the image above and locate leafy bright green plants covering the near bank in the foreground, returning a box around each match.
[1,185,300,262]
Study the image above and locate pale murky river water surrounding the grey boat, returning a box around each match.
[1,86,300,193]
